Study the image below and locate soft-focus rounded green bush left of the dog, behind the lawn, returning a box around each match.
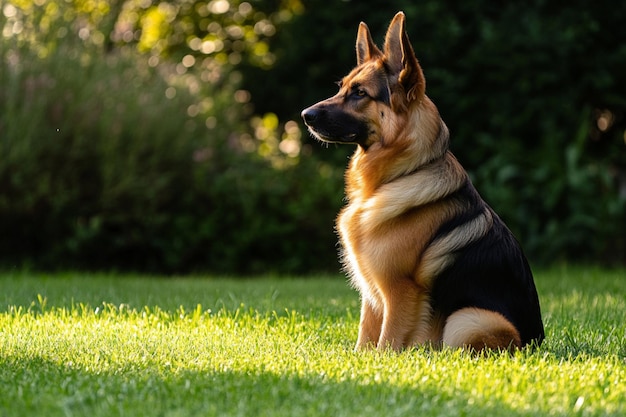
[0,1,341,273]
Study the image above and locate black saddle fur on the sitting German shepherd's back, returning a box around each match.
[431,181,544,346]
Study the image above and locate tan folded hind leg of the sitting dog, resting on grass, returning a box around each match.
[443,307,521,351]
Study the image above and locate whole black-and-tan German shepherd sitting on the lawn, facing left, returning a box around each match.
[302,12,544,351]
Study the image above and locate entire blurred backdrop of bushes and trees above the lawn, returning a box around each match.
[0,0,626,274]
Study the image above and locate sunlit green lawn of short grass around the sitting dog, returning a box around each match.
[0,267,626,417]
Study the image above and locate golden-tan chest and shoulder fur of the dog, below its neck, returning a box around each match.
[337,146,476,312]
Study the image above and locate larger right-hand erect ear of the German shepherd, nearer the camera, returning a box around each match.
[384,12,426,102]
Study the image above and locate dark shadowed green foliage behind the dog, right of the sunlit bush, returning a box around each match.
[244,0,626,263]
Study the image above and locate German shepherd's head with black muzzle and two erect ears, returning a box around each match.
[302,12,425,149]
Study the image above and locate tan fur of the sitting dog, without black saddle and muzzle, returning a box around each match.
[303,13,520,350]
